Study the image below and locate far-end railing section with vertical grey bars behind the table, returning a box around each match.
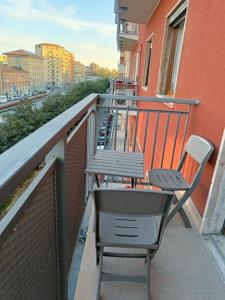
[98,94,199,182]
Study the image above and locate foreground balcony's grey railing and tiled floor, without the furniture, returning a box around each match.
[0,94,225,300]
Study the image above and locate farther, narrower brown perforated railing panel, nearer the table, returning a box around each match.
[65,119,87,267]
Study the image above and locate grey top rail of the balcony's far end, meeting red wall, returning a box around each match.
[99,94,200,105]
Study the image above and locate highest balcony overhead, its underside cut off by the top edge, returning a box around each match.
[114,0,160,24]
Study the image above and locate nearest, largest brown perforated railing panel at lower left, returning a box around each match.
[0,167,59,300]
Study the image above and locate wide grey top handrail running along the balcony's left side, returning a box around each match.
[0,94,98,203]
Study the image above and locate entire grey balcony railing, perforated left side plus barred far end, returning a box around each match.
[0,94,199,300]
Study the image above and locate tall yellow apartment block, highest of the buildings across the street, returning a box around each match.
[35,43,74,87]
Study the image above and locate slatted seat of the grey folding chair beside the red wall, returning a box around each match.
[149,169,190,191]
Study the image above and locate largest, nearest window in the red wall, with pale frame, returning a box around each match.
[160,1,187,96]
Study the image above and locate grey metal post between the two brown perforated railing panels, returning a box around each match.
[46,138,68,300]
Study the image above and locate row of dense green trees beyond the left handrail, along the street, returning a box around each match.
[0,79,109,153]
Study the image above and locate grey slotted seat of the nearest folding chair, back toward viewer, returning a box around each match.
[98,212,159,248]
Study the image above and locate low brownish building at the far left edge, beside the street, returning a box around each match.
[0,64,30,97]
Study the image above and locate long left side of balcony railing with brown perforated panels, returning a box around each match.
[0,94,98,300]
